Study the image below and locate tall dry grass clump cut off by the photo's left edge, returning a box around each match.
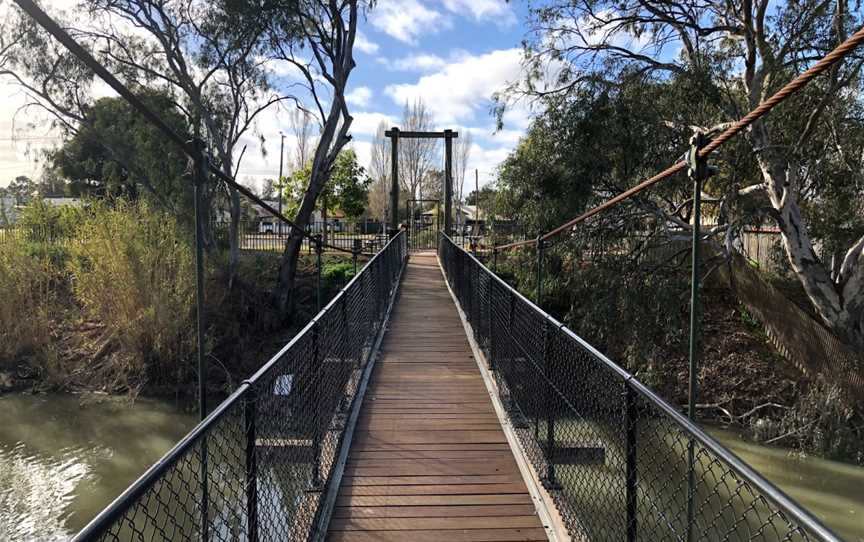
[0,239,55,368]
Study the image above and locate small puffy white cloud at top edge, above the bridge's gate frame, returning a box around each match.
[369,0,451,45]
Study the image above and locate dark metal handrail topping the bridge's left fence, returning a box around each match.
[72,232,404,542]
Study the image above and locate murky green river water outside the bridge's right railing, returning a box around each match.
[709,428,864,542]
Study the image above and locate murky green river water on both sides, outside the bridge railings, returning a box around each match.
[0,395,864,542]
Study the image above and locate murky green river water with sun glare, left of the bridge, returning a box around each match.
[0,395,197,541]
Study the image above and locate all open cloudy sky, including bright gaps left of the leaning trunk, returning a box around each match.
[0,0,529,194]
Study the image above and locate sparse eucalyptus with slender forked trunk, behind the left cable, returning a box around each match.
[0,0,293,277]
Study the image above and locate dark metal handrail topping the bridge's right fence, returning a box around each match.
[441,233,842,542]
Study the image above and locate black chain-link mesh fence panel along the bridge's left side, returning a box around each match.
[76,234,407,541]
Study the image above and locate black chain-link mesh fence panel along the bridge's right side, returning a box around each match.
[439,236,838,541]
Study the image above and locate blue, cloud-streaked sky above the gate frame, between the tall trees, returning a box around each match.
[284,0,528,189]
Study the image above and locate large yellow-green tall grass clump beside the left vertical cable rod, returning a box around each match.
[69,201,195,388]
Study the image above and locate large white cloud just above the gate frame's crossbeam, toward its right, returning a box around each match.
[385,48,522,124]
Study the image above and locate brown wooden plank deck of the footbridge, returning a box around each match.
[328,254,547,542]
